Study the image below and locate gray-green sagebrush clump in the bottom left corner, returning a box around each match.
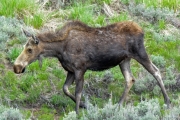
[0,105,23,120]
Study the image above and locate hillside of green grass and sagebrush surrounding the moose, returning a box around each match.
[0,0,180,120]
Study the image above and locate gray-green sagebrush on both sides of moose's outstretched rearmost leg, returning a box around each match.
[134,63,178,95]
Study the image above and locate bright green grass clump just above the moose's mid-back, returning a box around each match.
[69,1,121,27]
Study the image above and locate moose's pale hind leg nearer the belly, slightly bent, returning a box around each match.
[119,58,135,105]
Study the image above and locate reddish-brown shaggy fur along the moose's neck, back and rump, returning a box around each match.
[37,21,143,42]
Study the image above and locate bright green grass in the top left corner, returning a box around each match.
[0,0,48,28]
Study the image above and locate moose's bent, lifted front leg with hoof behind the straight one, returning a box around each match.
[63,72,86,108]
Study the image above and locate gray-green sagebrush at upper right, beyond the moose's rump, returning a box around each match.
[128,2,179,42]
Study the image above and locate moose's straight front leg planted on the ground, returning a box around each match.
[75,71,85,114]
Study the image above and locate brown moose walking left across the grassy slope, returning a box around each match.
[13,21,170,114]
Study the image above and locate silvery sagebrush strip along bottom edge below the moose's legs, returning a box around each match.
[64,99,161,120]
